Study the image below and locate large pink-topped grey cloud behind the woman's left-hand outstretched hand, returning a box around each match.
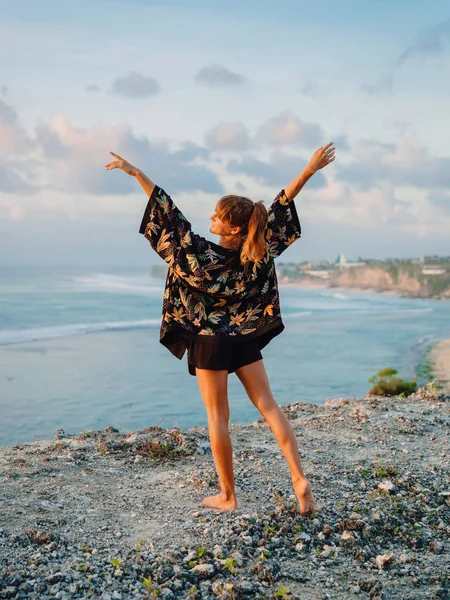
[33,117,223,195]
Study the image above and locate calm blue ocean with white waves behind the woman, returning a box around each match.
[0,267,450,446]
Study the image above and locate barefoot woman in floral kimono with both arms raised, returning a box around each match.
[105,142,335,514]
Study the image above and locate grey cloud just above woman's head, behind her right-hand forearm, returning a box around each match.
[227,152,327,188]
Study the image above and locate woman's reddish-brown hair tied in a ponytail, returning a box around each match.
[216,194,268,265]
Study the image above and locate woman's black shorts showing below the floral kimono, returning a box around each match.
[187,340,262,376]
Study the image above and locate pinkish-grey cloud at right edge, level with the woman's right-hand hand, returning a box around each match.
[336,137,450,189]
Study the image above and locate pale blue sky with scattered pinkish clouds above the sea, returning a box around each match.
[0,0,450,266]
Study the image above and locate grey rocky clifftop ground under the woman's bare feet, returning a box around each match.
[0,389,450,600]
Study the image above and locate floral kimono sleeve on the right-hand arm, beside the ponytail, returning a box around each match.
[266,190,302,258]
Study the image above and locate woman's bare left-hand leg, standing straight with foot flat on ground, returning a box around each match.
[195,368,237,509]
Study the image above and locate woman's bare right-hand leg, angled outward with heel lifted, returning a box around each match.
[236,360,317,514]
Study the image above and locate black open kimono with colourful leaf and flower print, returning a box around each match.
[139,186,301,359]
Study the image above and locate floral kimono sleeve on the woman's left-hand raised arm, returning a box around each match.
[139,185,198,265]
